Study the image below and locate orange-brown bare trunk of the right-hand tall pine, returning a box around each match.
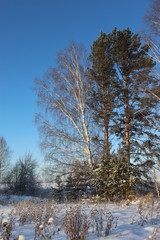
[125,75,130,172]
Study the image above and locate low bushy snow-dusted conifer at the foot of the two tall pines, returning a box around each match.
[95,148,133,201]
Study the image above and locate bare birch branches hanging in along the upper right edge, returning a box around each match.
[142,0,160,161]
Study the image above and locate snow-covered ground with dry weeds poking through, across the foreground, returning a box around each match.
[0,195,160,240]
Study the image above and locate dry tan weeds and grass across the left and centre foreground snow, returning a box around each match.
[0,200,115,240]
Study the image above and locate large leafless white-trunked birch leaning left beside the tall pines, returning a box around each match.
[35,42,93,172]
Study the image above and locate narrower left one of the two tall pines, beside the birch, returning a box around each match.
[89,32,116,158]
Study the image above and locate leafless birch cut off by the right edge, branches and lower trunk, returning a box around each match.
[145,0,160,197]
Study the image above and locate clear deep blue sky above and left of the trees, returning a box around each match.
[0,0,149,163]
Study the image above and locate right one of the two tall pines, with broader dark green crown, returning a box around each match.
[112,28,155,172]
